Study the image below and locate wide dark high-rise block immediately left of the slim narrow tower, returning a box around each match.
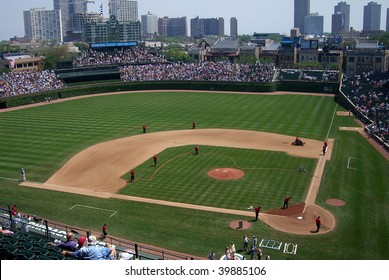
[190,17,224,38]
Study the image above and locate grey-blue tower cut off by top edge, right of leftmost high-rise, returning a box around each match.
[53,0,87,36]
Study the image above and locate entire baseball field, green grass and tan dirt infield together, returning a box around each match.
[0,91,389,260]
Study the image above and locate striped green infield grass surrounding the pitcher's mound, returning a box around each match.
[120,146,316,211]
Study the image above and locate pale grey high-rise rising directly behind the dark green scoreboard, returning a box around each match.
[108,0,139,22]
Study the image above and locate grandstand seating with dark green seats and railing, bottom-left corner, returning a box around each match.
[0,208,198,260]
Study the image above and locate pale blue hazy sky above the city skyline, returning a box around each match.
[0,0,389,40]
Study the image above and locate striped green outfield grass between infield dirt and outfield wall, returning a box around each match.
[0,92,334,182]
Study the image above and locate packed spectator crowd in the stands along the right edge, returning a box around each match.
[342,72,389,144]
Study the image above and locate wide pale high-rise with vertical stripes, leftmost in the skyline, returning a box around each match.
[23,8,63,42]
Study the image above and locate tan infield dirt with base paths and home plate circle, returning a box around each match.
[22,129,336,234]
